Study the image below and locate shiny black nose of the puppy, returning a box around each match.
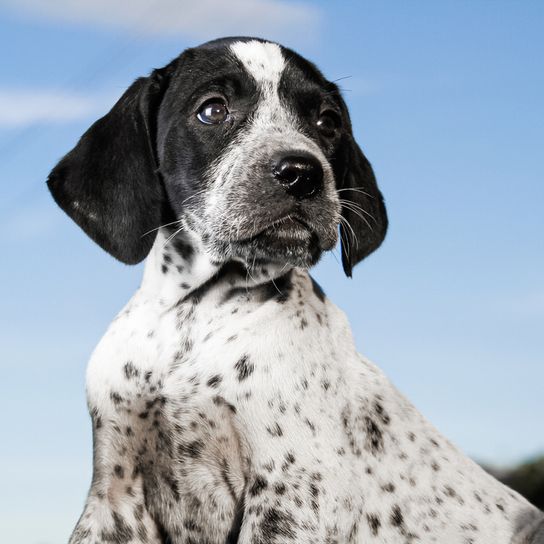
[273,155,323,199]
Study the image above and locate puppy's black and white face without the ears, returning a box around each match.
[158,40,342,266]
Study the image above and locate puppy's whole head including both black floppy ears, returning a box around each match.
[48,38,387,275]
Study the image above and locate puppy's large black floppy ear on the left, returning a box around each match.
[47,71,168,264]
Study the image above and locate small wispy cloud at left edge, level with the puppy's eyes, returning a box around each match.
[0,88,113,129]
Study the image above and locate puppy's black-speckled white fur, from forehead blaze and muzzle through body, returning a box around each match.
[51,41,544,544]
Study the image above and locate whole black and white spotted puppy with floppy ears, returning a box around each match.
[48,38,544,544]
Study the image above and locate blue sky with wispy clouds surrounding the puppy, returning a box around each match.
[0,0,544,544]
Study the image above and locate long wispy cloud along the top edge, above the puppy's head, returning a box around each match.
[2,0,320,39]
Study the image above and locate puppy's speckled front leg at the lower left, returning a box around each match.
[69,414,164,544]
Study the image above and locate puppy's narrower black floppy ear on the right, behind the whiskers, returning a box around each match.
[338,131,387,277]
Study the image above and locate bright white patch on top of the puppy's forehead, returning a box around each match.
[230,40,285,86]
